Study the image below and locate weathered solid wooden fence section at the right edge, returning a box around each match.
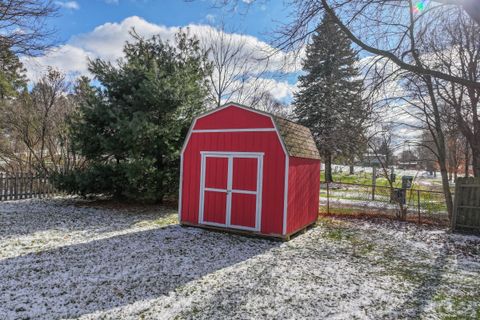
[452,178,480,232]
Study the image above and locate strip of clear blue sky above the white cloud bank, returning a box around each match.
[50,0,287,42]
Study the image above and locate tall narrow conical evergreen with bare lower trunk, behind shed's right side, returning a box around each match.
[294,15,368,181]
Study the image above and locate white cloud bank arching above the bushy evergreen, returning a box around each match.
[23,16,299,100]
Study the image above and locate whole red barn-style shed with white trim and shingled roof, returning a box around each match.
[178,103,320,239]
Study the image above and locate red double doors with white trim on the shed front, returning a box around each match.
[199,152,263,231]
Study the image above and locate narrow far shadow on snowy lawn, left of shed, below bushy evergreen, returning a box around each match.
[0,199,176,239]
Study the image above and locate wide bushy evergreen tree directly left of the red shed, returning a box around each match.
[57,32,209,201]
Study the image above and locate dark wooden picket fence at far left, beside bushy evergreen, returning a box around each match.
[0,173,56,201]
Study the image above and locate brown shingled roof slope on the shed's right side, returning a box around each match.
[271,115,320,160]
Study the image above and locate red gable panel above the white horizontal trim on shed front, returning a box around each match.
[193,106,274,130]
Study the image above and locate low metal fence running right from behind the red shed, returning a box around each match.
[320,182,448,222]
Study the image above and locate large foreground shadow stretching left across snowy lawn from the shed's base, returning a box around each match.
[0,225,280,319]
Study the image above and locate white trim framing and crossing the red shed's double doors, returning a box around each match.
[198,151,264,231]
